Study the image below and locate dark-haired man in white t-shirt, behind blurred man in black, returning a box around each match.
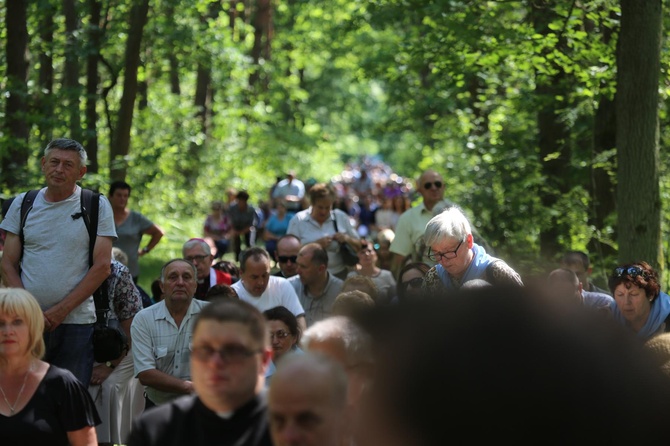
[232,247,306,330]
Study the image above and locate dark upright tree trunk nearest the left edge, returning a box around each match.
[2,0,29,189]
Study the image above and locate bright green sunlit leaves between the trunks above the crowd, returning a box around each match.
[0,0,670,282]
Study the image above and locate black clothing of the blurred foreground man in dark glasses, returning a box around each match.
[128,395,272,446]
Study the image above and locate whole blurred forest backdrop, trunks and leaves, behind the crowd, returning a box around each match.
[0,0,670,284]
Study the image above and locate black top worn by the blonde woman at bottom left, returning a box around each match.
[0,365,100,446]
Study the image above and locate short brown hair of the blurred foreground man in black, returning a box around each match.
[193,299,267,346]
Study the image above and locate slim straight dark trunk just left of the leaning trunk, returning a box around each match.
[84,0,102,173]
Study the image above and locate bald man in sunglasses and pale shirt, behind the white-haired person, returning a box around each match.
[390,170,456,277]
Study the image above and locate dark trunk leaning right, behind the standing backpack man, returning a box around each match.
[109,0,149,180]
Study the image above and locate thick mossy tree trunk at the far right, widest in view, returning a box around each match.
[616,0,663,268]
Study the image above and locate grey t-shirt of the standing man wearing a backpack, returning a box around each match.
[0,186,116,324]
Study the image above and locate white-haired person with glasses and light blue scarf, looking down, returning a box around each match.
[423,206,523,292]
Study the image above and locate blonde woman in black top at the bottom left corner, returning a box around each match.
[0,288,100,446]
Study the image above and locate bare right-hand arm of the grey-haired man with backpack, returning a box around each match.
[44,236,112,331]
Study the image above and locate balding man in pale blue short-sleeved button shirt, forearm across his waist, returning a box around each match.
[130,259,207,407]
